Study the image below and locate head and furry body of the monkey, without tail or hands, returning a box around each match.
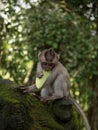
[38,49,70,101]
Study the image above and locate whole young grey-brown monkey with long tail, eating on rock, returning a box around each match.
[21,49,90,130]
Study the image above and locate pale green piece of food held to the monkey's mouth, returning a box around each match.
[36,71,51,89]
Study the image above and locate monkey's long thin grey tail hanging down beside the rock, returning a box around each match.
[69,96,91,130]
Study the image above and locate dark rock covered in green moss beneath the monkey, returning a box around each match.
[0,79,78,130]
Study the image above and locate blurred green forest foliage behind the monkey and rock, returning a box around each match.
[0,0,98,130]
